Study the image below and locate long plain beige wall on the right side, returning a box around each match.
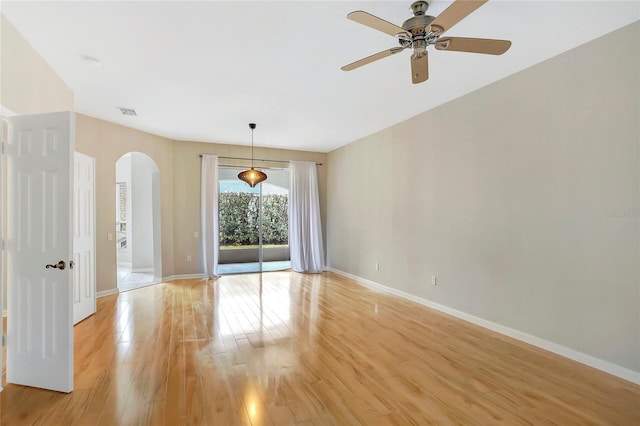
[328,23,640,372]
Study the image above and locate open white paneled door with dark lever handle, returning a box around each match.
[7,112,75,392]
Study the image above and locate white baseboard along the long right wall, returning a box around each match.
[327,267,640,384]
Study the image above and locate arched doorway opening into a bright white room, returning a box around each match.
[115,152,162,292]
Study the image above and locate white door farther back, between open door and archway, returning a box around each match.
[73,152,96,325]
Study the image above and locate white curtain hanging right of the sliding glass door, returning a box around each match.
[289,161,324,273]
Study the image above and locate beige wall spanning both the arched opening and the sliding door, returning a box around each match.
[76,114,327,292]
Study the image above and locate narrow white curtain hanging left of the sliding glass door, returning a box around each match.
[200,155,220,278]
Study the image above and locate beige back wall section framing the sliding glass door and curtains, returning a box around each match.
[173,142,327,275]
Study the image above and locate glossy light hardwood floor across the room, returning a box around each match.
[1,272,640,425]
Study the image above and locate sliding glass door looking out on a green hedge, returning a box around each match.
[218,166,291,275]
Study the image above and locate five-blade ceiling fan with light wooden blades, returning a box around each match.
[341,0,511,84]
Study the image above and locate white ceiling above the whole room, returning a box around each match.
[1,0,640,152]
